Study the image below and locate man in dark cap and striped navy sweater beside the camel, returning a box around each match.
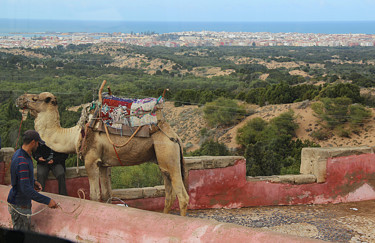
[7,130,57,230]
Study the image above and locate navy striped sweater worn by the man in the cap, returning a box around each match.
[7,148,51,206]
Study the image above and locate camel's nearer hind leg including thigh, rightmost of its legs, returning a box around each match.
[153,133,189,216]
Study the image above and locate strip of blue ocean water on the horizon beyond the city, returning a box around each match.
[0,19,375,34]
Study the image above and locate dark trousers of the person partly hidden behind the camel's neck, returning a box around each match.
[37,163,68,195]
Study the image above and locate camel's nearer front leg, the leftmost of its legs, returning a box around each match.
[84,152,100,201]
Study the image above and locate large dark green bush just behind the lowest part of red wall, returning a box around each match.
[236,111,318,176]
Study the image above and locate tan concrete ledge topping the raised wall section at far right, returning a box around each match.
[300,147,374,183]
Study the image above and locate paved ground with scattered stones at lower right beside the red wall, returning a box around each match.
[184,201,375,242]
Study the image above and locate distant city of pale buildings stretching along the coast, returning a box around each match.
[0,31,375,49]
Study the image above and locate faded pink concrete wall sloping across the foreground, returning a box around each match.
[0,185,319,243]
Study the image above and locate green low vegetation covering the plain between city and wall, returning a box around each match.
[0,44,375,188]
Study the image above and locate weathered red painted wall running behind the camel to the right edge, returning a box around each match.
[6,154,375,211]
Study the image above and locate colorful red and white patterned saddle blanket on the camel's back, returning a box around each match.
[101,96,163,129]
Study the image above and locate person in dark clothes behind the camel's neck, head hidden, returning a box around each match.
[33,144,68,195]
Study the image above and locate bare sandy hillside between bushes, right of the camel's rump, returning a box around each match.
[164,101,375,151]
